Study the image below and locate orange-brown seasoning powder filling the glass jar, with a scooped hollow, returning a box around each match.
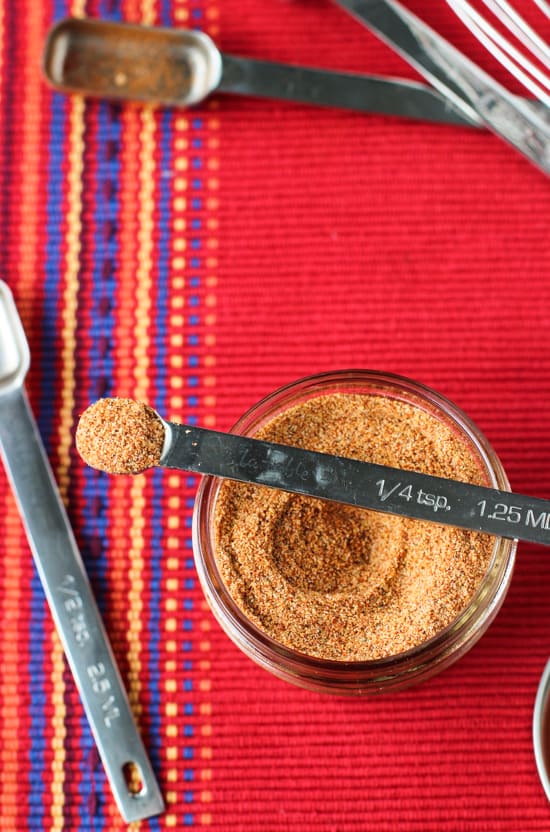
[215,393,493,661]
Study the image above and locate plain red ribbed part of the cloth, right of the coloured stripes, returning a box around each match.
[212,1,550,832]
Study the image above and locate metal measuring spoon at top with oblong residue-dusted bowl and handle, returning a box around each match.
[43,18,481,127]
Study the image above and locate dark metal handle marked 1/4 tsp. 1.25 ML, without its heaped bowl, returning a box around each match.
[159,417,550,546]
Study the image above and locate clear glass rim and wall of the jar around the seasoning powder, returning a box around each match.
[193,370,517,695]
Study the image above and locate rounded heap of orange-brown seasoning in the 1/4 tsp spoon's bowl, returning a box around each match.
[76,398,165,474]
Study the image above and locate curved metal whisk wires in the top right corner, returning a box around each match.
[447,0,550,107]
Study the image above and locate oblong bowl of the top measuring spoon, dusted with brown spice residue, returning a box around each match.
[42,18,222,106]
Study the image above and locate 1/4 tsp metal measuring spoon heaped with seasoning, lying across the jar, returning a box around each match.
[76,398,550,546]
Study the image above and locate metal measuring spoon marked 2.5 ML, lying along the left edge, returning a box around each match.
[0,280,164,823]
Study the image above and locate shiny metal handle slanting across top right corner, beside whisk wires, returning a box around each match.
[335,0,550,175]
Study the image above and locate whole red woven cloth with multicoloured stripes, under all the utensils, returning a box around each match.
[0,0,550,832]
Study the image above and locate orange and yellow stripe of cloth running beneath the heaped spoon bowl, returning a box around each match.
[105,2,155,830]
